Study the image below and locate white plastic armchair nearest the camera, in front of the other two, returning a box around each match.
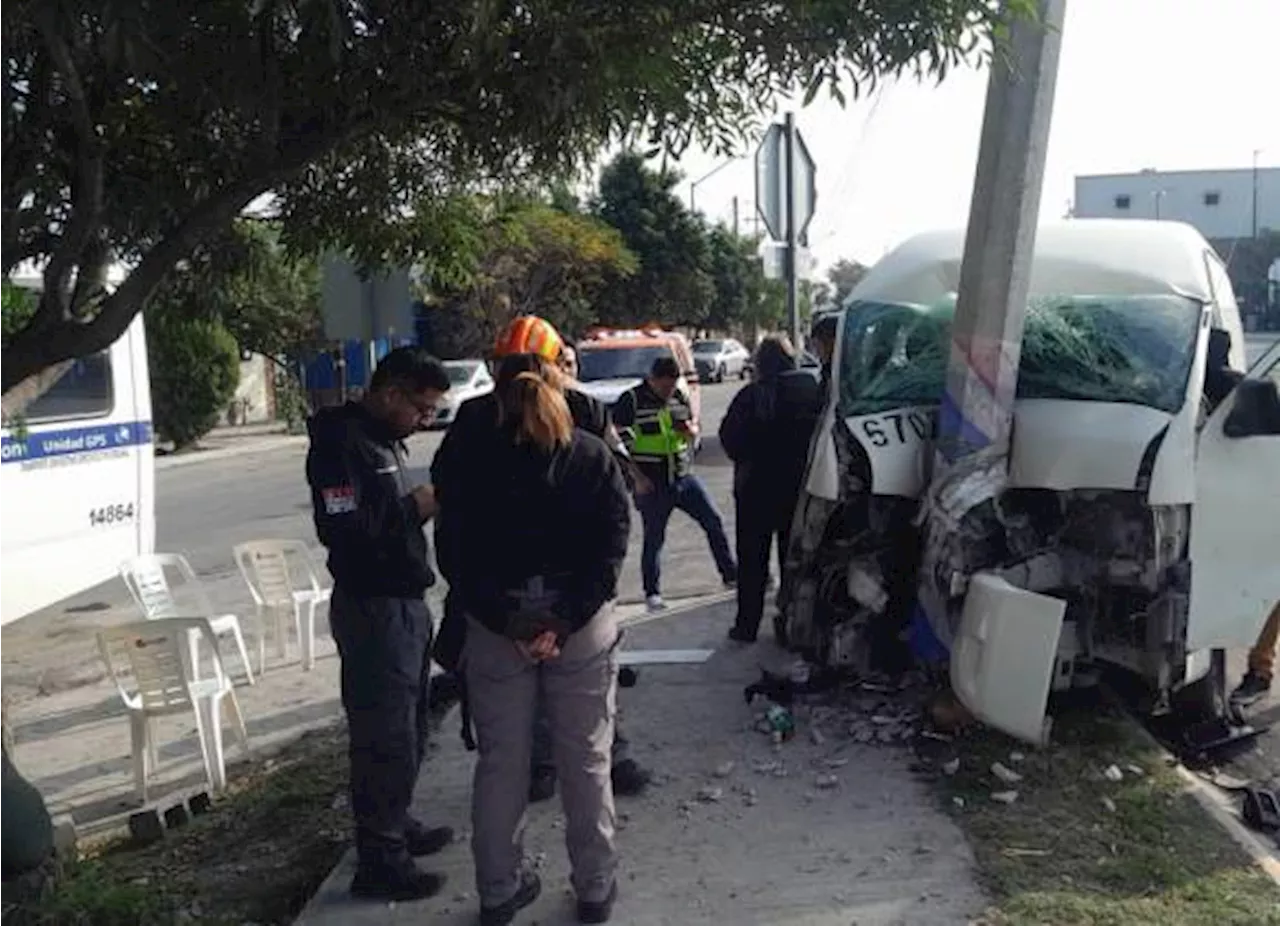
[97,617,248,803]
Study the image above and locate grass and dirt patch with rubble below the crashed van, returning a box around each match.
[936,704,1280,926]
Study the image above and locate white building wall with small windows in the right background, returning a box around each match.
[1073,168,1280,238]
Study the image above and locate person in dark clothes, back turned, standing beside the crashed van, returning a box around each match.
[719,336,822,643]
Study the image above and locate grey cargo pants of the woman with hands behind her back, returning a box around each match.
[462,605,621,907]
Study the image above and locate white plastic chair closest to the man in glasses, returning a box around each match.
[236,540,333,672]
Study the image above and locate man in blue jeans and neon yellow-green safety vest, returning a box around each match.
[613,356,737,611]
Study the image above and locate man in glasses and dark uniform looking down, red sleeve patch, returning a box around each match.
[306,347,453,900]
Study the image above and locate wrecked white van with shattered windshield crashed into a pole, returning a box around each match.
[783,219,1280,742]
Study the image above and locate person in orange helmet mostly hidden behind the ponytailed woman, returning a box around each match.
[431,315,653,800]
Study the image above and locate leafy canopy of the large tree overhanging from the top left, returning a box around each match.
[0,0,1018,393]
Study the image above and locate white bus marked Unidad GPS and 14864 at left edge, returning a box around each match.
[0,269,156,626]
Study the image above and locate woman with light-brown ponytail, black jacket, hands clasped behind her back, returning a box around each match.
[436,371,631,926]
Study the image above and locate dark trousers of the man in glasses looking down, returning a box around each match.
[329,588,431,866]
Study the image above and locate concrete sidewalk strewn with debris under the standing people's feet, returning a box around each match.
[298,602,983,926]
